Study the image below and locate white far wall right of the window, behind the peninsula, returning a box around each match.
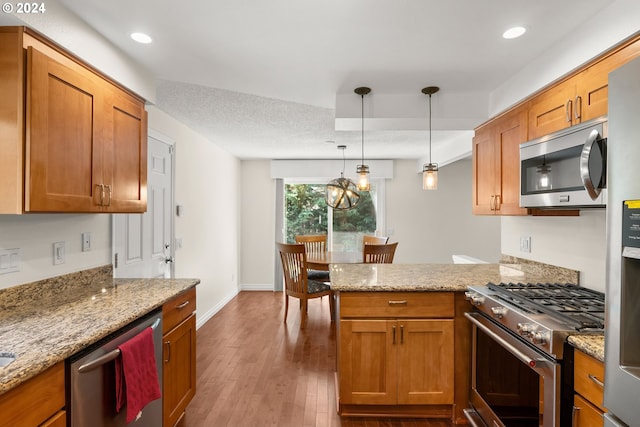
[387,159,500,264]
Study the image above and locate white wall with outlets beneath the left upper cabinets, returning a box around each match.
[0,214,111,288]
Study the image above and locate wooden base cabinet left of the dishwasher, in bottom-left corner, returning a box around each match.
[0,362,67,427]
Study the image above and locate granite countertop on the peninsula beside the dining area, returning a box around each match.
[330,263,578,292]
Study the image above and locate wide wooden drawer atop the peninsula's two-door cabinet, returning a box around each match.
[340,292,455,319]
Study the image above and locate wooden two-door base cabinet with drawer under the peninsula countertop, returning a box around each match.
[337,292,469,419]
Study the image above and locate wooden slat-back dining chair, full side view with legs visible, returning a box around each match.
[276,243,334,329]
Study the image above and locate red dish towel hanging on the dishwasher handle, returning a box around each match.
[116,328,161,423]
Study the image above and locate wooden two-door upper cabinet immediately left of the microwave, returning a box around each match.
[472,107,528,215]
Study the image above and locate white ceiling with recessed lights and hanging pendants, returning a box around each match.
[7,0,629,162]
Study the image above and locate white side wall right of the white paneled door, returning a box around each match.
[147,106,241,325]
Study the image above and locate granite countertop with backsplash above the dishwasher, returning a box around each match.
[0,266,200,394]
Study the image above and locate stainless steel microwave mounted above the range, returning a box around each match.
[520,117,607,209]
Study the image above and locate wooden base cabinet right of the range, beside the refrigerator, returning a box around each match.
[572,350,606,427]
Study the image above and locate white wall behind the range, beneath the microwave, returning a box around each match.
[502,210,606,292]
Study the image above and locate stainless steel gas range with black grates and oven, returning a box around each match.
[465,283,605,427]
